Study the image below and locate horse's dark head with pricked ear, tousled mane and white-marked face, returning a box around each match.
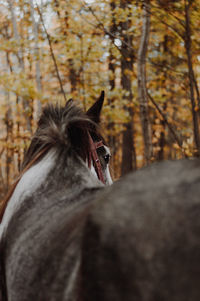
[22,91,112,185]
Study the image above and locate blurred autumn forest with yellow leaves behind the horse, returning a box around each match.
[0,0,200,198]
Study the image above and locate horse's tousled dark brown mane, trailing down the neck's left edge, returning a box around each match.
[0,100,105,222]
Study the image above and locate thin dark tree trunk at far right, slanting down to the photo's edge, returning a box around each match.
[185,0,200,156]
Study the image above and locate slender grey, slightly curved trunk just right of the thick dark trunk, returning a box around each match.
[138,0,152,164]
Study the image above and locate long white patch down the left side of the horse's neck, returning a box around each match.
[0,150,55,237]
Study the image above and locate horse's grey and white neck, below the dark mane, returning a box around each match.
[2,149,102,232]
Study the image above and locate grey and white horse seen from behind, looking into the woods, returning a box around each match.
[0,91,200,301]
